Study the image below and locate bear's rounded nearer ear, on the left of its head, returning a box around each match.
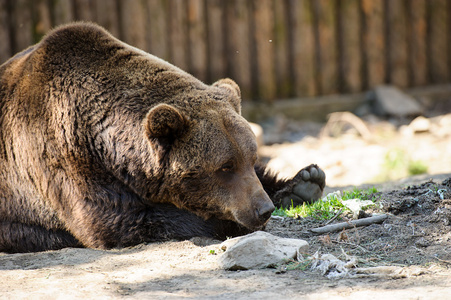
[144,104,188,142]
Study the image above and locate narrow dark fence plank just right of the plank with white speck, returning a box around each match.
[273,1,293,98]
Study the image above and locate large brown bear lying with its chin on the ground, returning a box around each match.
[0,23,325,252]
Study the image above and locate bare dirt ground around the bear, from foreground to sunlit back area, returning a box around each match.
[0,112,451,299]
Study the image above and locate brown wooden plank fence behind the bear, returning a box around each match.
[0,0,451,101]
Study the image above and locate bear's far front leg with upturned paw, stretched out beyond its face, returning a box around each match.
[255,164,326,207]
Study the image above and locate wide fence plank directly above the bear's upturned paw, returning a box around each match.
[288,0,318,97]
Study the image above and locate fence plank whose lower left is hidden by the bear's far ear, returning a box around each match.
[224,0,255,99]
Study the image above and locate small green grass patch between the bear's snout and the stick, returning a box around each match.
[273,187,377,220]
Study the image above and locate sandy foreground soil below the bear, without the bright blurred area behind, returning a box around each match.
[0,175,451,299]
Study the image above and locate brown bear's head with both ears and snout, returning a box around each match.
[144,79,274,230]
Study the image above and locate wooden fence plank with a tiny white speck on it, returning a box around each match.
[253,0,276,101]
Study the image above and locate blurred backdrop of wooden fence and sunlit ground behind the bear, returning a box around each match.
[0,0,451,186]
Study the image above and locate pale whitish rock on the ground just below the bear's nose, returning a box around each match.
[218,231,308,270]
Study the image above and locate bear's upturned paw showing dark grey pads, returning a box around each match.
[275,165,326,208]
